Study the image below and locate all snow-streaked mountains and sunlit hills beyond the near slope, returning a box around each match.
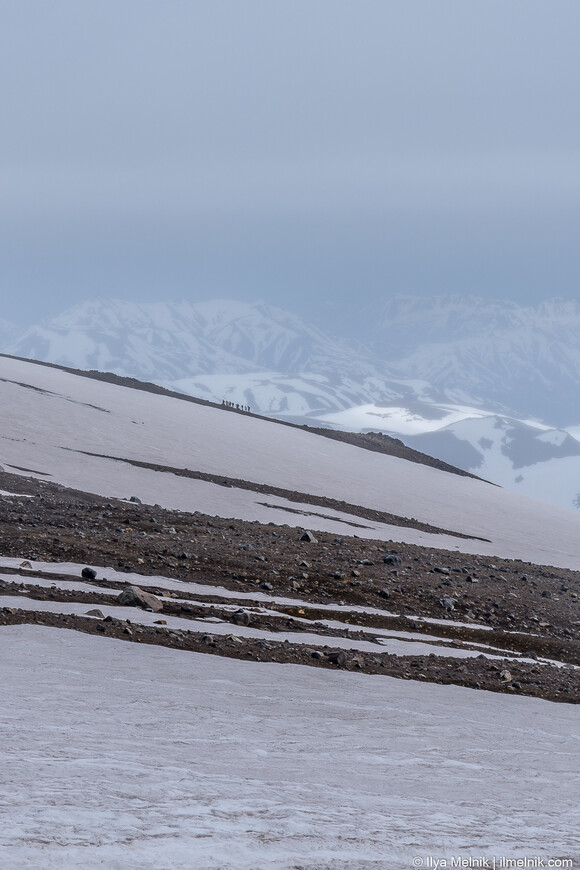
[0,296,580,508]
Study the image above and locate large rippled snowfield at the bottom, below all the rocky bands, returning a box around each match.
[0,626,580,870]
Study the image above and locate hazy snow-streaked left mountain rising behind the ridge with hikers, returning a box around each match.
[2,300,458,416]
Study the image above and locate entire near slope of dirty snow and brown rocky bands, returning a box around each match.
[0,358,580,870]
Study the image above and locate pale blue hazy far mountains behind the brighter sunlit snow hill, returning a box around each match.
[5,296,580,426]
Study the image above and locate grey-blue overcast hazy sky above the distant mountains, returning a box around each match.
[0,0,580,323]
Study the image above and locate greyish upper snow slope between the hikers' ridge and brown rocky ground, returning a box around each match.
[0,358,580,568]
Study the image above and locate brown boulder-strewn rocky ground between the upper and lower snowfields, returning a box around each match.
[0,472,580,703]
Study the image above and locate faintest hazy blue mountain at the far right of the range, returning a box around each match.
[371,296,580,425]
